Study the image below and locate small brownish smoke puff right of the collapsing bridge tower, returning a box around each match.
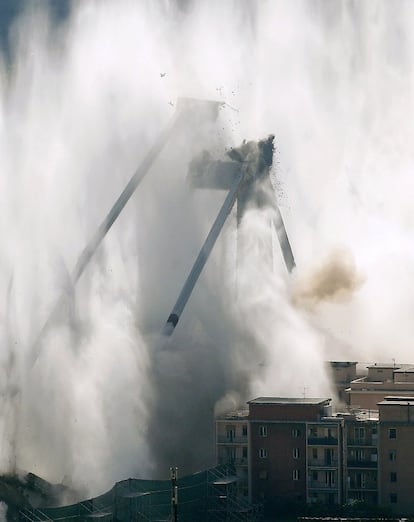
[292,249,364,308]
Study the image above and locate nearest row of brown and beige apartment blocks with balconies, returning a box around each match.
[216,390,414,515]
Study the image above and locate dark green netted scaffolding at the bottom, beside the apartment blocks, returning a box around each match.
[19,465,261,522]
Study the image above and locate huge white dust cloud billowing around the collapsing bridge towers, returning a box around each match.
[0,0,414,493]
